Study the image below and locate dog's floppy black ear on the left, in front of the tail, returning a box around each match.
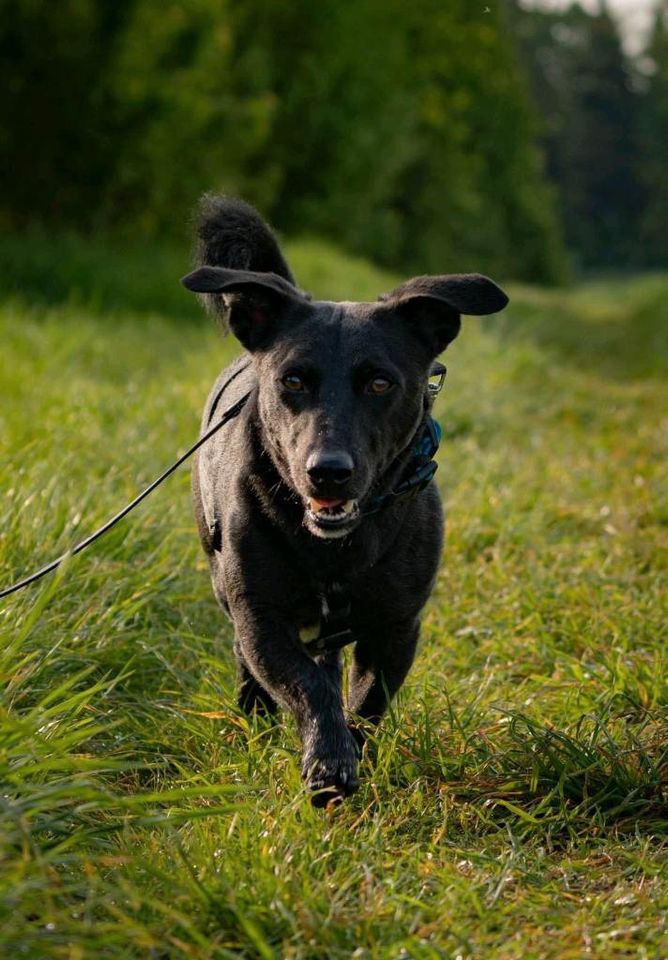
[181,267,308,351]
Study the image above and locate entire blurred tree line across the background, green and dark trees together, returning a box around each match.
[0,0,668,282]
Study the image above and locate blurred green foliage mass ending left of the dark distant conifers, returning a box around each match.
[0,0,563,281]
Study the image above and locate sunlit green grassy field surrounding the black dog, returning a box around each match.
[0,234,668,960]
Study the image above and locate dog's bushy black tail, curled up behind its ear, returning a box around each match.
[195,193,296,325]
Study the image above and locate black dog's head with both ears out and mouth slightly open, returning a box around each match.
[183,266,508,538]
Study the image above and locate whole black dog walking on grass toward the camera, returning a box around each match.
[183,196,508,804]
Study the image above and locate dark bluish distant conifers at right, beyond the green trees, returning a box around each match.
[508,0,668,269]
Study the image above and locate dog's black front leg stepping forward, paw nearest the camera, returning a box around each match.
[232,602,359,806]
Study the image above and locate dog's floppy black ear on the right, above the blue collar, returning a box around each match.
[381,273,508,354]
